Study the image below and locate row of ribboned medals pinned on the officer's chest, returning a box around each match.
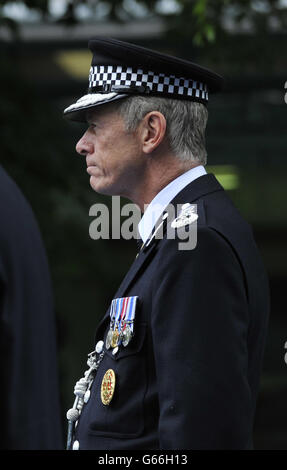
[106,296,138,351]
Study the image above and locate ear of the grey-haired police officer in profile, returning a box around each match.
[141,111,166,154]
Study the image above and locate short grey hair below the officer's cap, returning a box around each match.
[113,96,208,165]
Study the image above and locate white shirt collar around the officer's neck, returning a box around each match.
[138,165,206,243]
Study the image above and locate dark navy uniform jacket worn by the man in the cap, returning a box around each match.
[75,174,269,450]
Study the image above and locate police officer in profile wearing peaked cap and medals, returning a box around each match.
[64,38,269,450]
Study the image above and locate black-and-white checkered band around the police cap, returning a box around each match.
[89,65,208,102]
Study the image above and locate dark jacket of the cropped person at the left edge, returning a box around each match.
[0,167,62,450]
